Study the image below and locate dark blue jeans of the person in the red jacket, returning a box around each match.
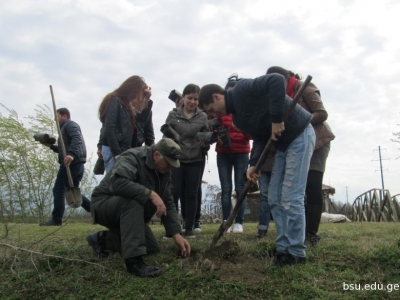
[217,153,249,224]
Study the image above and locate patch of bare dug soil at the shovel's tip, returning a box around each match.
[184,241,265,285]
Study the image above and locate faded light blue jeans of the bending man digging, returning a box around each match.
[268,124,315,257]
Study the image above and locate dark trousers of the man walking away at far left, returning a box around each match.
[51,163,90,223]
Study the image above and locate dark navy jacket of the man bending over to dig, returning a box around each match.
[225,74,312,166]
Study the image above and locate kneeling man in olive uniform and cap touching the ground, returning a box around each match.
[86,138,190,277]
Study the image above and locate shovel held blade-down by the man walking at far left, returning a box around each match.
[50,85,82,208]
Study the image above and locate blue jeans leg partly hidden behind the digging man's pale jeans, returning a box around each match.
[257,171,271,230]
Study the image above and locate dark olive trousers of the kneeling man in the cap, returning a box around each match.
[92,196,160,259]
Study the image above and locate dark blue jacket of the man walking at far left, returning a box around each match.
[50,120,86,165]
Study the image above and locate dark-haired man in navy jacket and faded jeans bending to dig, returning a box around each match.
[199,74,315,266]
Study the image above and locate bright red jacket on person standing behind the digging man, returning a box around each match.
[215,114,250,154]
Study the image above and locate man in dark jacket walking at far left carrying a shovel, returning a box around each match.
[39,108,90,226]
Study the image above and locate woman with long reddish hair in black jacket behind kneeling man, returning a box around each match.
[98,75,154,172]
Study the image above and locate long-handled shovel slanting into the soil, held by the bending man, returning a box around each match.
[210,75,312,248]
